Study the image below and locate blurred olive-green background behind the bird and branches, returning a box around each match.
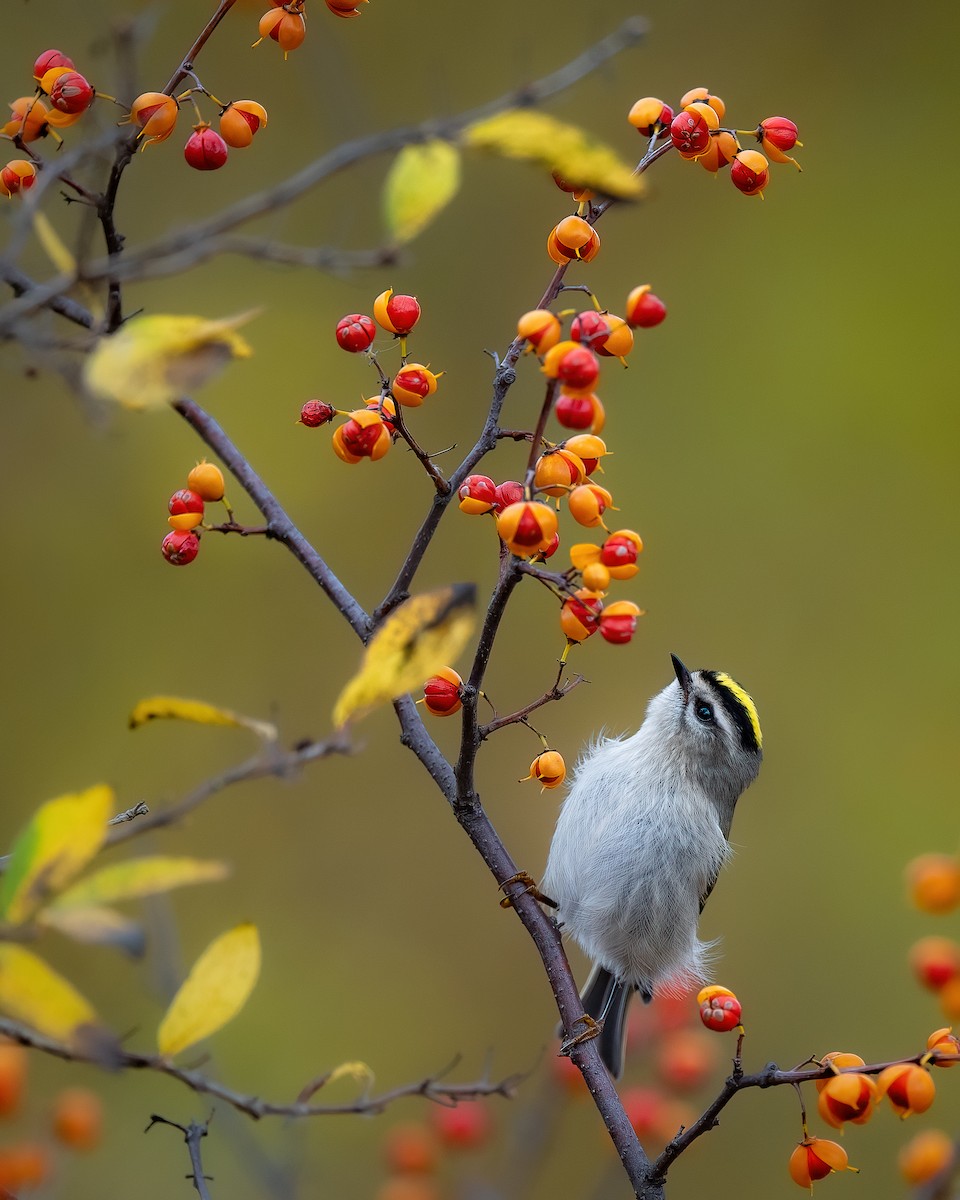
[0,0,960,1200]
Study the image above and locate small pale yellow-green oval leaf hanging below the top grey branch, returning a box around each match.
[383,138,460,245]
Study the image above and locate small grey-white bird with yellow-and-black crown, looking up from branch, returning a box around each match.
[542,655,762,1078]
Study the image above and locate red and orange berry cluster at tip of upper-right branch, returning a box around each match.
[626,88,803,197]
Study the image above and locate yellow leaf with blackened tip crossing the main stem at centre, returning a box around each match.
[334,583,476,728]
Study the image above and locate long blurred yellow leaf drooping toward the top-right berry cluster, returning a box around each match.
[463,108,644,200]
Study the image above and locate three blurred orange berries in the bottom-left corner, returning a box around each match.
[0,1042,103,1195]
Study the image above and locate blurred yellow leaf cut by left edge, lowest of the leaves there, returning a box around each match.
[0,942,97,1042]
